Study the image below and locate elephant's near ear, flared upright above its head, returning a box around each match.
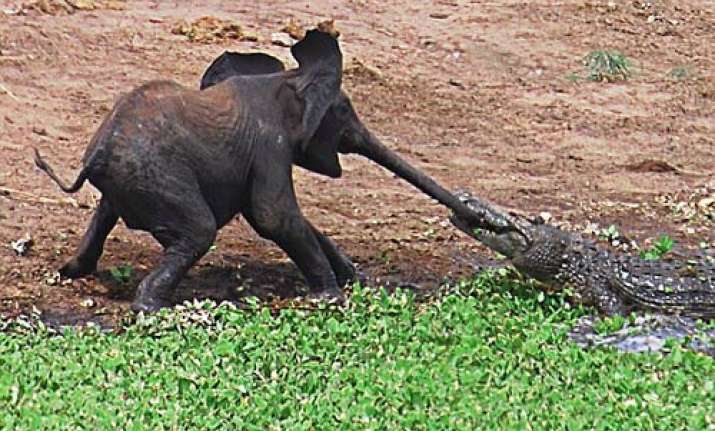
[288,30,343,177]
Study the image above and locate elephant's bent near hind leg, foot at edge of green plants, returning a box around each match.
[132,196,216,313]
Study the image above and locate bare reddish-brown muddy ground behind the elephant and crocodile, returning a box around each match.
[0,0,715,328]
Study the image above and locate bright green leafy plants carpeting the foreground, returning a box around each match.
[0,275,715,430]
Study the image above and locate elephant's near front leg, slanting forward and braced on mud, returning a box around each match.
[244,164,344,301]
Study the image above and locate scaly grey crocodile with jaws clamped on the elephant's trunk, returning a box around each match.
[450,191,715,319]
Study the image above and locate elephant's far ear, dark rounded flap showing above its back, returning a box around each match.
[200,51,285,90]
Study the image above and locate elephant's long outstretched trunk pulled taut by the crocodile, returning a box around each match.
[351,127,489,227]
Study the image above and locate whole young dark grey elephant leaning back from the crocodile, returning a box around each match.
[35,31,511,312]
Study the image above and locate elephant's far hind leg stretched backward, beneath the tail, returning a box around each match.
[60,197,119,278]
